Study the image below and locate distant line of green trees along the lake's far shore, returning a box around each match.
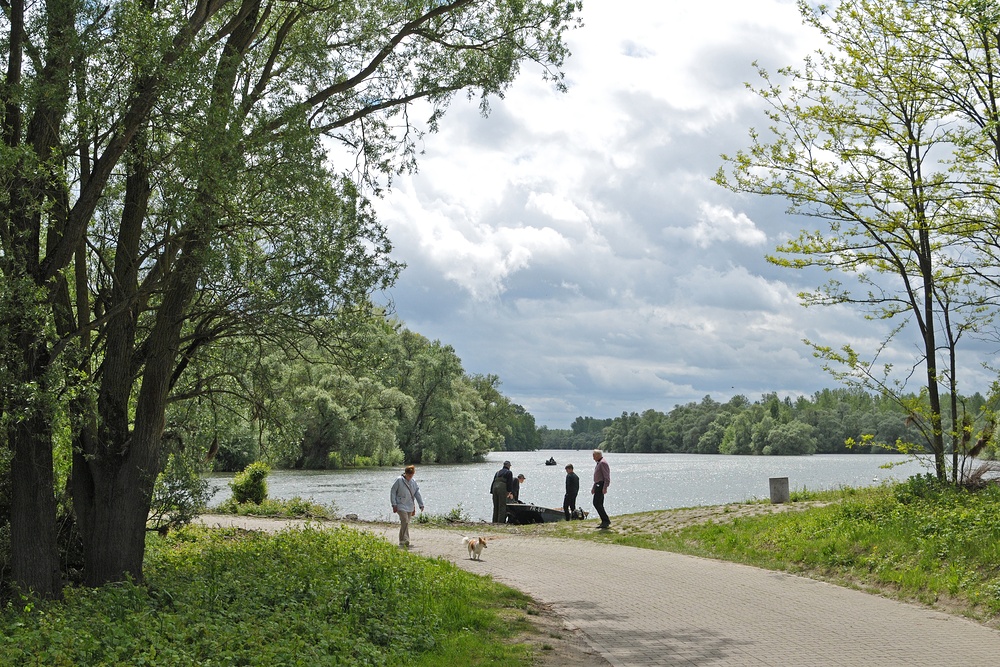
[539,388,997,458]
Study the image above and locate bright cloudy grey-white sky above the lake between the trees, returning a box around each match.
[368,0,990,429]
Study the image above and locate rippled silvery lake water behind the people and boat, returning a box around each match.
[209,450,927,521]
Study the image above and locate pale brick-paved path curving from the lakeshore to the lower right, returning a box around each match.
[197,517,1000,667]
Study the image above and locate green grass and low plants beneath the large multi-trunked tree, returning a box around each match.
[0,527,544,667]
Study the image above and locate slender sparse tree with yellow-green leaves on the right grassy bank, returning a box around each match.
[717,0,1000,481]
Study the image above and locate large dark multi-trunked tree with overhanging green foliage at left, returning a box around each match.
[0,0,579,596]
